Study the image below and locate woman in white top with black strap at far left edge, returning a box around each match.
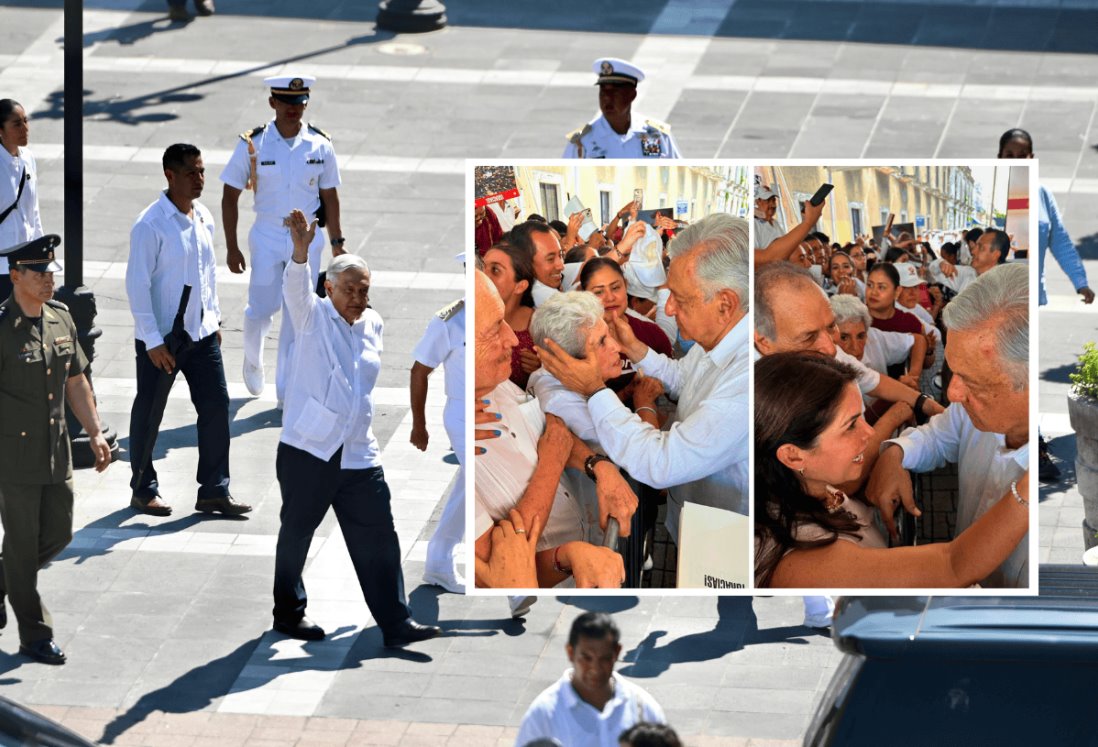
[0,99,43,301]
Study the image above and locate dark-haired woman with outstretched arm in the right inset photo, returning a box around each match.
[754,352,1029,588]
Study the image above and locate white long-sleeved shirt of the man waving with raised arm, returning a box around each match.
[279,261,384,469]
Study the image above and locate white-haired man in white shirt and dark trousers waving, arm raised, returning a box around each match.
[273,210,441,648]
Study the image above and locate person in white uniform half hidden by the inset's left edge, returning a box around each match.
[411,299,466,594]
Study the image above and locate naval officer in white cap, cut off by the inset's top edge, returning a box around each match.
[562,57,682,158]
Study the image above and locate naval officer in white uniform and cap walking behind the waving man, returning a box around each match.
[221,76,344,404]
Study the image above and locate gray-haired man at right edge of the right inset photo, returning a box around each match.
[865,264,1029,587]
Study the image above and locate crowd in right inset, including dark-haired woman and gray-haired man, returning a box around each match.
[754,176,1029,588]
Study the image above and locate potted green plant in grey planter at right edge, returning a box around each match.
[1067,343,1098,550]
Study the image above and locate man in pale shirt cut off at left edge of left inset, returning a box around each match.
[473,271,637,593]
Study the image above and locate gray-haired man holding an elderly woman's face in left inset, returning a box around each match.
[534,214,751,540]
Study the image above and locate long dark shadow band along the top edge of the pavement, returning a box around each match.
[8,0,1098,54]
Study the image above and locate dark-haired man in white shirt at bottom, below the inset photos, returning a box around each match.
[515,612,666,747]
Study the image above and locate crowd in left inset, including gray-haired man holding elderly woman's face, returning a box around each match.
[474,196,749,587]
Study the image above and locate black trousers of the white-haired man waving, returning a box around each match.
[273,444,412,631]
